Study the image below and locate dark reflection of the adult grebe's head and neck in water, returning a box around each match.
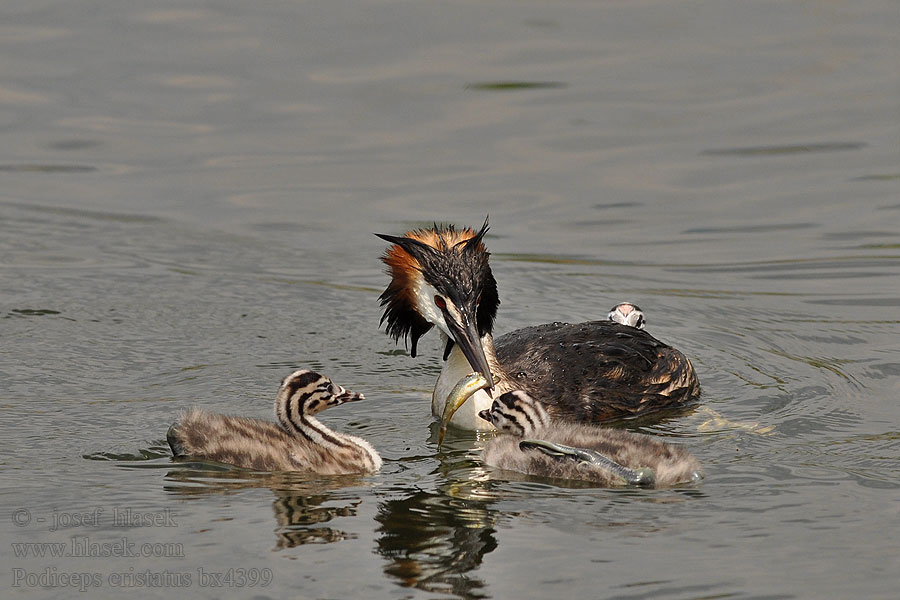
[375,424,497,598]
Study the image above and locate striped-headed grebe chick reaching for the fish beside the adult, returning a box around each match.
[476,386,703,487]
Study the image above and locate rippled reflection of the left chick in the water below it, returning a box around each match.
[165,463,363,550]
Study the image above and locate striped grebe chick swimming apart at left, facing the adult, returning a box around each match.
[166,370,381,475]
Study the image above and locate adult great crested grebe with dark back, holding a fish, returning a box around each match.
[376,220,700,430]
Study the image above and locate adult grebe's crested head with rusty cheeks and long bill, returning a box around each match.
[376,219,500,387]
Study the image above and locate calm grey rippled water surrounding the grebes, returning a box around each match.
[0,0,900,599]
